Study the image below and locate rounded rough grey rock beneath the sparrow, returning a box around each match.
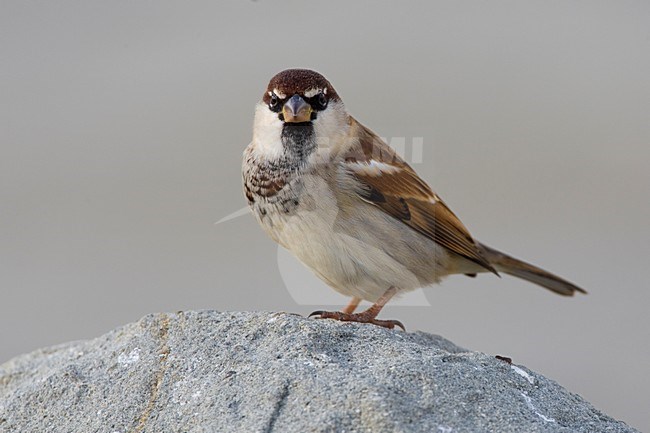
[0,311,635,433]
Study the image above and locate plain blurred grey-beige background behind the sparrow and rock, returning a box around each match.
[0,0,650,430]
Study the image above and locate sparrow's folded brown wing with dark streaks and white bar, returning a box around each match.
[342,119,497,273]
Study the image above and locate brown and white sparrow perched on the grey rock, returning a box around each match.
[242,69,586,329]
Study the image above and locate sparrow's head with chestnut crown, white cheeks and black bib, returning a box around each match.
[253,69,348,158]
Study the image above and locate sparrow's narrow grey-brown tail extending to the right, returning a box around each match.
[480,244,587,296]
